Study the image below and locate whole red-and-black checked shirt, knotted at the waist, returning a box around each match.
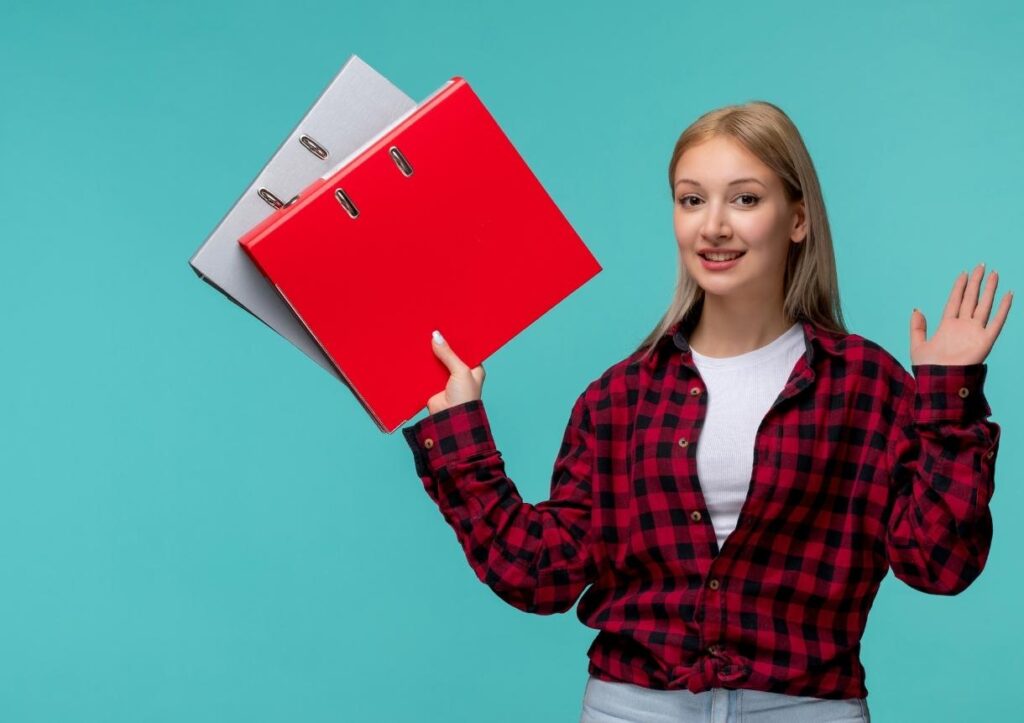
[402,314,999,698]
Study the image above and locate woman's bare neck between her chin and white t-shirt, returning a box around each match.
[687,294,793,357]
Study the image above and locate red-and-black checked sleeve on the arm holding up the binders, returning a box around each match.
[402,394,597,614]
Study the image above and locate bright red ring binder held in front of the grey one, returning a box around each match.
[239,77,601,433]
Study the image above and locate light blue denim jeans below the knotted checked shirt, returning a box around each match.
[580,676,871,723]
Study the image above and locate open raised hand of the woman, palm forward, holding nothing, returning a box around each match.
[910,263,1013,366]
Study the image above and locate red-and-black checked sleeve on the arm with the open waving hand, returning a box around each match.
[886,364,999,595]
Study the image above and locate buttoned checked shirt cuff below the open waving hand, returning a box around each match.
[911,364,992,423]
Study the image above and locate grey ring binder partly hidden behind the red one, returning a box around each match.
[188,55,416,381]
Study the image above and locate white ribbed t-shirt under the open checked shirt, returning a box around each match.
[690,322,805,550]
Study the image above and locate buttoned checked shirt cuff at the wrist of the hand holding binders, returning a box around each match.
[401,399,496,477]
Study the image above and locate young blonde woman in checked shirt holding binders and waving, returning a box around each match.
[402,102,1012,723]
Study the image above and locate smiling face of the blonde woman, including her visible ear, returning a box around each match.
[673,136,807,300]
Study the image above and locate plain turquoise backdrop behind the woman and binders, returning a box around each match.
[0,0,1024,723]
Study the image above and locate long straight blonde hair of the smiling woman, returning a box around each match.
[633,100,848,359]
